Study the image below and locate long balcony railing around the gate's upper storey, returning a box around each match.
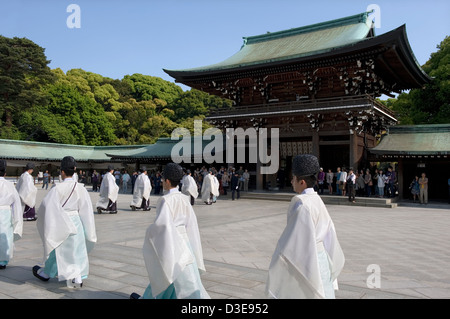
[207,95,395,119]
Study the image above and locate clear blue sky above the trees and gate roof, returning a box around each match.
[0,0,450,89]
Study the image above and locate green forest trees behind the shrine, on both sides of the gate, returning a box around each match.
[0,36,450,145]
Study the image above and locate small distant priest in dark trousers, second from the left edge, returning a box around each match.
[16,163,37,221]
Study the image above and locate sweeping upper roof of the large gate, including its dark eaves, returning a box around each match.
[164,12,431,90]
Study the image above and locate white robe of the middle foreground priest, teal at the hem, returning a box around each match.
[143,188,210,299]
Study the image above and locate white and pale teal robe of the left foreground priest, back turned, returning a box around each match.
[37,178,97,281]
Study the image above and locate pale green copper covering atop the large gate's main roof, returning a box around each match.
[165,12,372,73]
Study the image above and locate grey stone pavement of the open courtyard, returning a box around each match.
[0,186,450,299]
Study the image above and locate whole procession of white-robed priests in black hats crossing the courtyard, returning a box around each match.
[0,154,345,299]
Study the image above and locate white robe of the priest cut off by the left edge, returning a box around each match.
[0,177,23,266]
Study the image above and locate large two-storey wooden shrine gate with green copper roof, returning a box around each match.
[164,12,431,189]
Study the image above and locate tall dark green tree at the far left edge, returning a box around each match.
[0,36,54,138]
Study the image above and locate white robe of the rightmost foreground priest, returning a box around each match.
[266,188,345,299]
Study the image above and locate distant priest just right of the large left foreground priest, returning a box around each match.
[96,165,119,214]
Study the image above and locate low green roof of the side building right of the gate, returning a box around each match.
[370,124,450,157]
